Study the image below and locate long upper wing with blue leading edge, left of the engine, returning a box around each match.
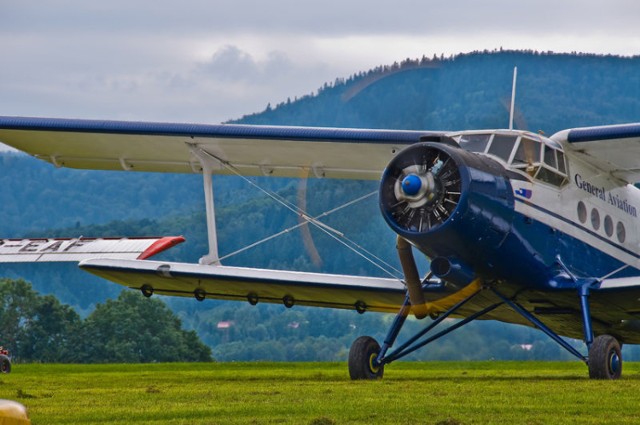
[0,117,439,180]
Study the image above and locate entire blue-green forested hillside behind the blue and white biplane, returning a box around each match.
[0,52,640,360]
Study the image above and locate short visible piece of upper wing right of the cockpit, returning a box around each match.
[552,123,640,183]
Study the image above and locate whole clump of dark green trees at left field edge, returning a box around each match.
[0,279,213,363]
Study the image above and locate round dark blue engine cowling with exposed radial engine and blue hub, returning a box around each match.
[380,142,514,284]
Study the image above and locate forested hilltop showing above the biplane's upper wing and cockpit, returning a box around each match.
[236,51,640,135]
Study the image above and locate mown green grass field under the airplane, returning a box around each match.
[0,362,640,425]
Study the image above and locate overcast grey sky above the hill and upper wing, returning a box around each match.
[0,0,640,123]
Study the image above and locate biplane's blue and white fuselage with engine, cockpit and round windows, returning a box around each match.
[381,131,640,289]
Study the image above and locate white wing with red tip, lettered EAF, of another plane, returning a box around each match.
[0,236,184,263]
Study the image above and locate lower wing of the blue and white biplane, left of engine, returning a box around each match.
[80,258,406,313]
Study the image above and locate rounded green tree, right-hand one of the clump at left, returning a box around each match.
[79,291,212,363]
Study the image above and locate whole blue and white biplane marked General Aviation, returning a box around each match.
[0,117,640,379]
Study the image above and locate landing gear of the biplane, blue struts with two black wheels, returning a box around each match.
[349,237,622,380]
